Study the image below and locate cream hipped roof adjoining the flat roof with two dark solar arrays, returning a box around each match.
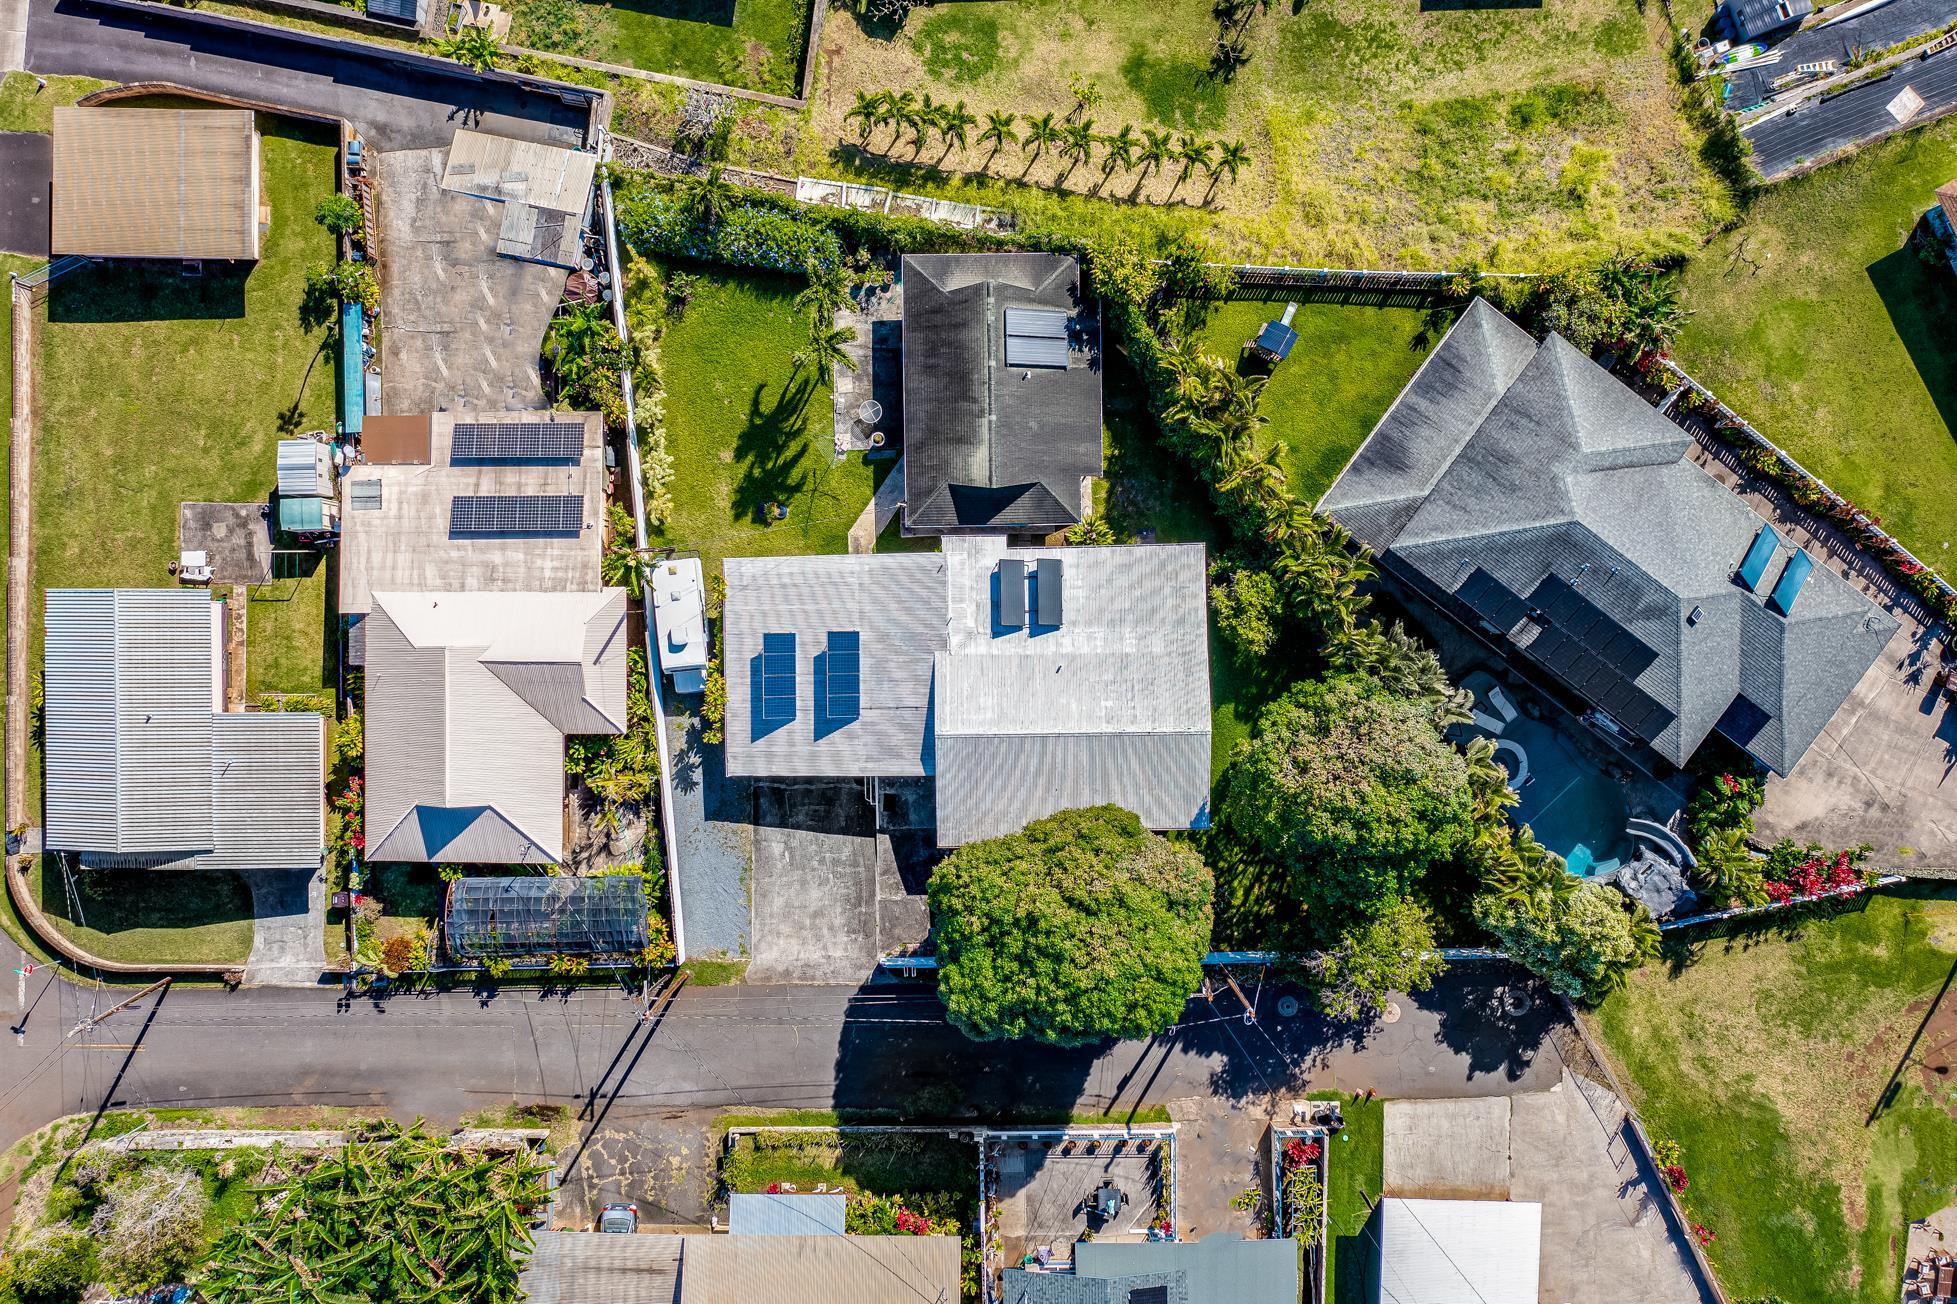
[366,589,626,863]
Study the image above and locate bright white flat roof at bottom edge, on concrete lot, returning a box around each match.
[1380,1198,1542,1304]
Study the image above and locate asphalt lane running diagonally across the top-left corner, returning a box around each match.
[27,0,585,151]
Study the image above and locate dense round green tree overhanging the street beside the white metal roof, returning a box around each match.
[930,807,1211,1046]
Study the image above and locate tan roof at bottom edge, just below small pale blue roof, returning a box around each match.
[679,1235,959,1304]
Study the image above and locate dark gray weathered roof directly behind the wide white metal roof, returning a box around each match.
[904,253,1102,535]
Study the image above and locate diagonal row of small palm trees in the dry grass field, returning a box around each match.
[843,90,1251,186]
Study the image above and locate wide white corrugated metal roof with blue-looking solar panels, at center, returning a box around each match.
[722,535,1209,846]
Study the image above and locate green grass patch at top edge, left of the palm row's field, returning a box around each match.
[509,0,810,96]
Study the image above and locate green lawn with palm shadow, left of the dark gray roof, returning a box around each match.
[634,266,871,568]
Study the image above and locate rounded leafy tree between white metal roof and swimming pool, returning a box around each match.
[1219,675,1474,936]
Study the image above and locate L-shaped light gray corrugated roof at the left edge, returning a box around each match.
[45,589,325,869]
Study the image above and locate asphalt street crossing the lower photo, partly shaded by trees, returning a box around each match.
[0,946,1560,1147]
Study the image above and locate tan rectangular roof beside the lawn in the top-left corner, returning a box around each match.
[51,108,258,260]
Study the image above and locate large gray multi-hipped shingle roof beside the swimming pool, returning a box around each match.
[1319,300,1896,773]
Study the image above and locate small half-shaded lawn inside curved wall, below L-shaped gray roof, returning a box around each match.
[27,856,252,965]
